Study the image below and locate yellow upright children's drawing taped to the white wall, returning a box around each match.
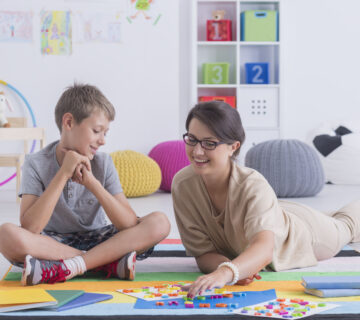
[40,11,72,55]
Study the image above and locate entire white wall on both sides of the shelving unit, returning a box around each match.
[0,0,360,188]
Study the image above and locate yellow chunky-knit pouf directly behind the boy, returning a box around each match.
[110,150,161,198]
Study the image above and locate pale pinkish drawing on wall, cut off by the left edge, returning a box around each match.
[0,11,33,42]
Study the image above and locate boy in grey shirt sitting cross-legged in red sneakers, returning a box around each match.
[0,84,170,285]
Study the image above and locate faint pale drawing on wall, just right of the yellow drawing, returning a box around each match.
[74,12,121,43]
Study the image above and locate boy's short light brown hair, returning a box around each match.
[55,83,115,132]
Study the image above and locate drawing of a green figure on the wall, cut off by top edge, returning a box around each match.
[127,0,161,26]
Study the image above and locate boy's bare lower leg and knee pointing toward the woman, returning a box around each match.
[82,212,170,270]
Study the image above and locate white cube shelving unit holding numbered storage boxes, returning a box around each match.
[191,0,281,162]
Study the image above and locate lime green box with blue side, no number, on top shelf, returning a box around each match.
[241,10,279,41]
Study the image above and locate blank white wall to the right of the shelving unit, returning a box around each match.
[281,0,360,139]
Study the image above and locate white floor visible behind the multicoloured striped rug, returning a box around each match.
[0,185,360,279]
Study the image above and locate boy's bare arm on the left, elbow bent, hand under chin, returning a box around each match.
[20,151,90,233]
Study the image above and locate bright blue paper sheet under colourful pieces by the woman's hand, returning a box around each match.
[134,289,277,310]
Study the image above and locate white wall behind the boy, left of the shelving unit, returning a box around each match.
[0,0,179,188]
